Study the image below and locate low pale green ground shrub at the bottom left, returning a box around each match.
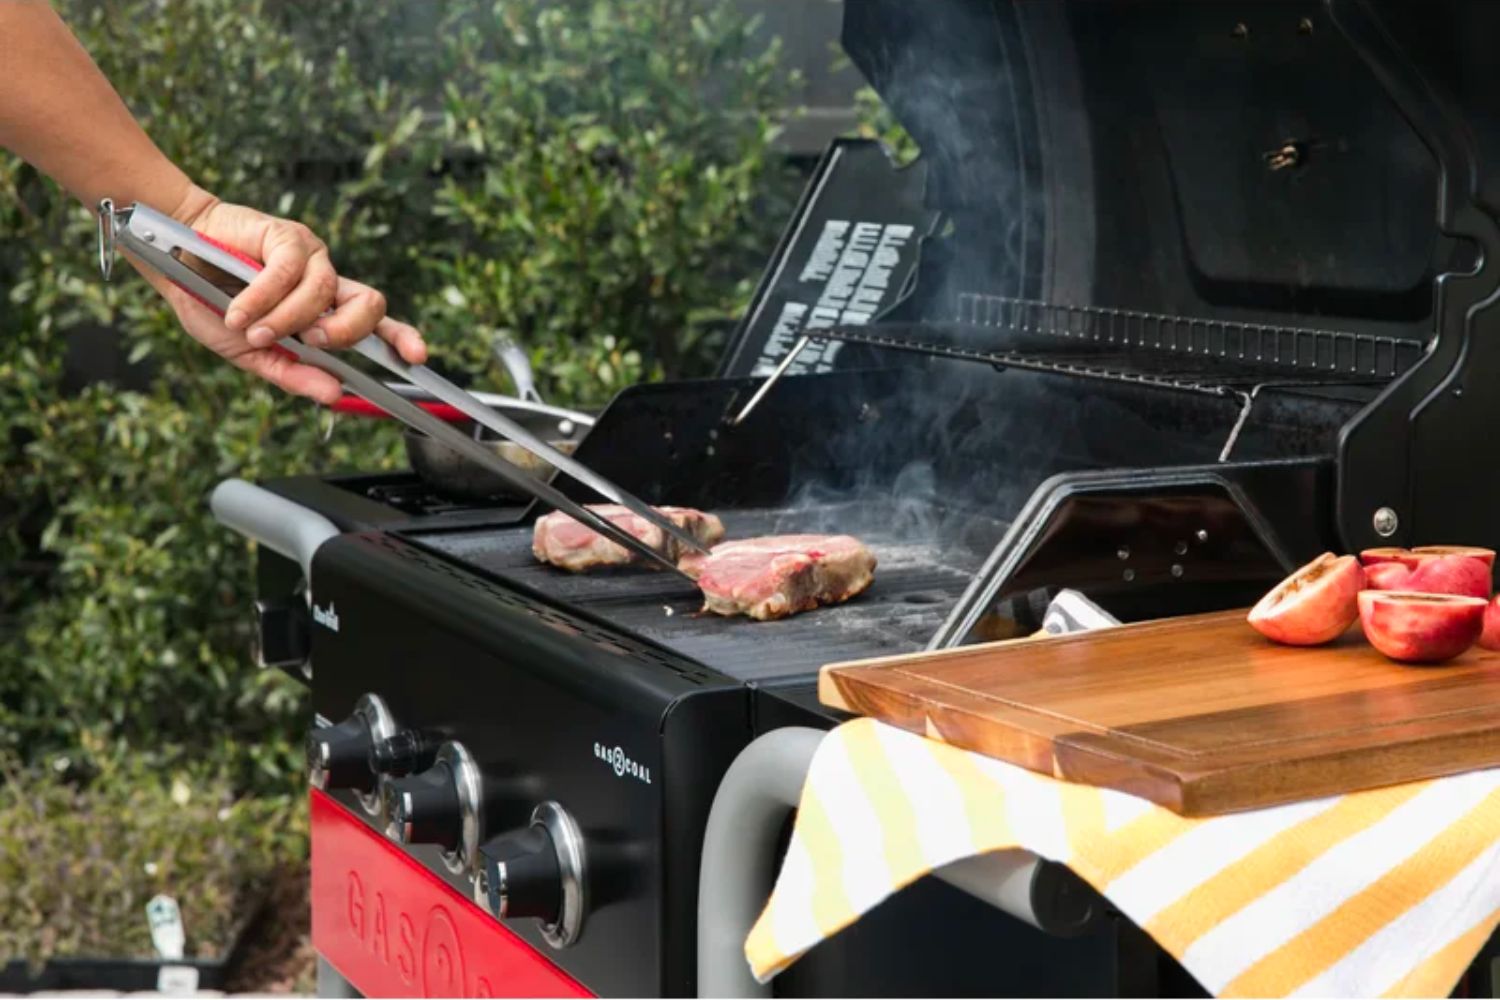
[0,757,306,963]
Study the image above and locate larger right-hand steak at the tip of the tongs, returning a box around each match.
[678,535,875,621]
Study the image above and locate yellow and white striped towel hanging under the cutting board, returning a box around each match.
[746,720,1500,997]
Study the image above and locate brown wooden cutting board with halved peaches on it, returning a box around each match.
[819,612,1500,816]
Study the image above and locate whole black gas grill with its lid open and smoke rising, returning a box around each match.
[222,0,1500,994]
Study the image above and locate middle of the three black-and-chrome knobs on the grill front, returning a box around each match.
[380,742,482,873]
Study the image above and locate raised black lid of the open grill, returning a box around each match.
[818,0,1500,560]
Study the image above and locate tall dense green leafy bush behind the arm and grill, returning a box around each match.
[0,0,794,795]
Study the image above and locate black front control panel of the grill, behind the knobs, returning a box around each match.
[312,532,750,996]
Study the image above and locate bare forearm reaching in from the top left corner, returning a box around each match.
[0,0,203,214]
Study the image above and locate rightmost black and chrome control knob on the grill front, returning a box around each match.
[474,802,587,948]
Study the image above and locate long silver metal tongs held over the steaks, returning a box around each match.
[99,198,705,576]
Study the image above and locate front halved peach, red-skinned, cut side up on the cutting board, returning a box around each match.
[1359,591,1488,663]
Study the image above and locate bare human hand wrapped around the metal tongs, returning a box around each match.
[137,187,428,403]
